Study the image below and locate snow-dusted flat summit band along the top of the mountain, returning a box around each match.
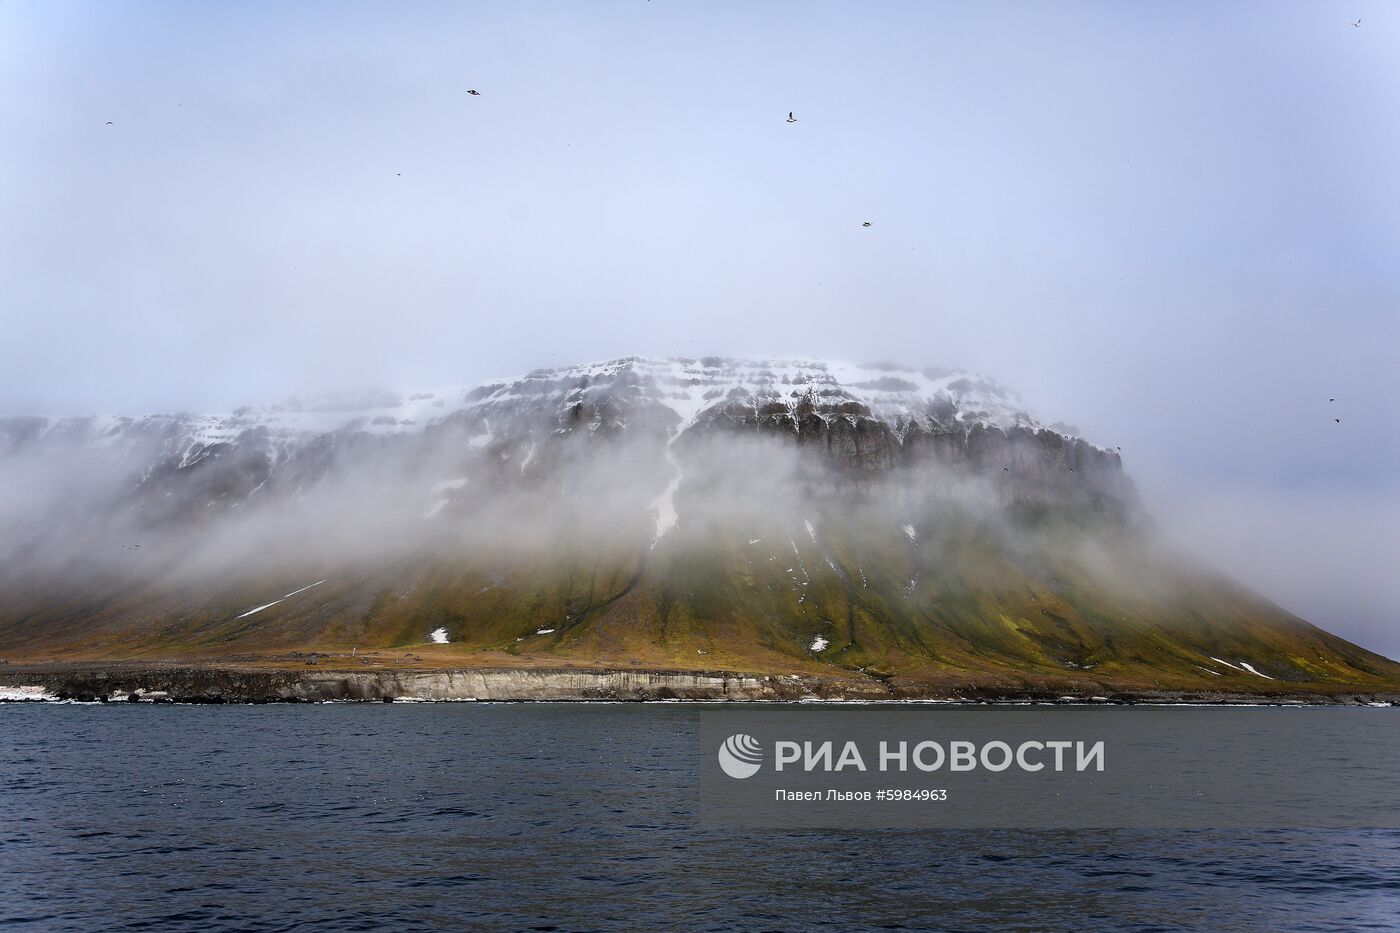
[0,357,1068,453]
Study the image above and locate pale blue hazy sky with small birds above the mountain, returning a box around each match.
[0,0,1400,657]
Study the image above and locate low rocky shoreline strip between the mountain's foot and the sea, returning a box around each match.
[0,665,1400,706]
